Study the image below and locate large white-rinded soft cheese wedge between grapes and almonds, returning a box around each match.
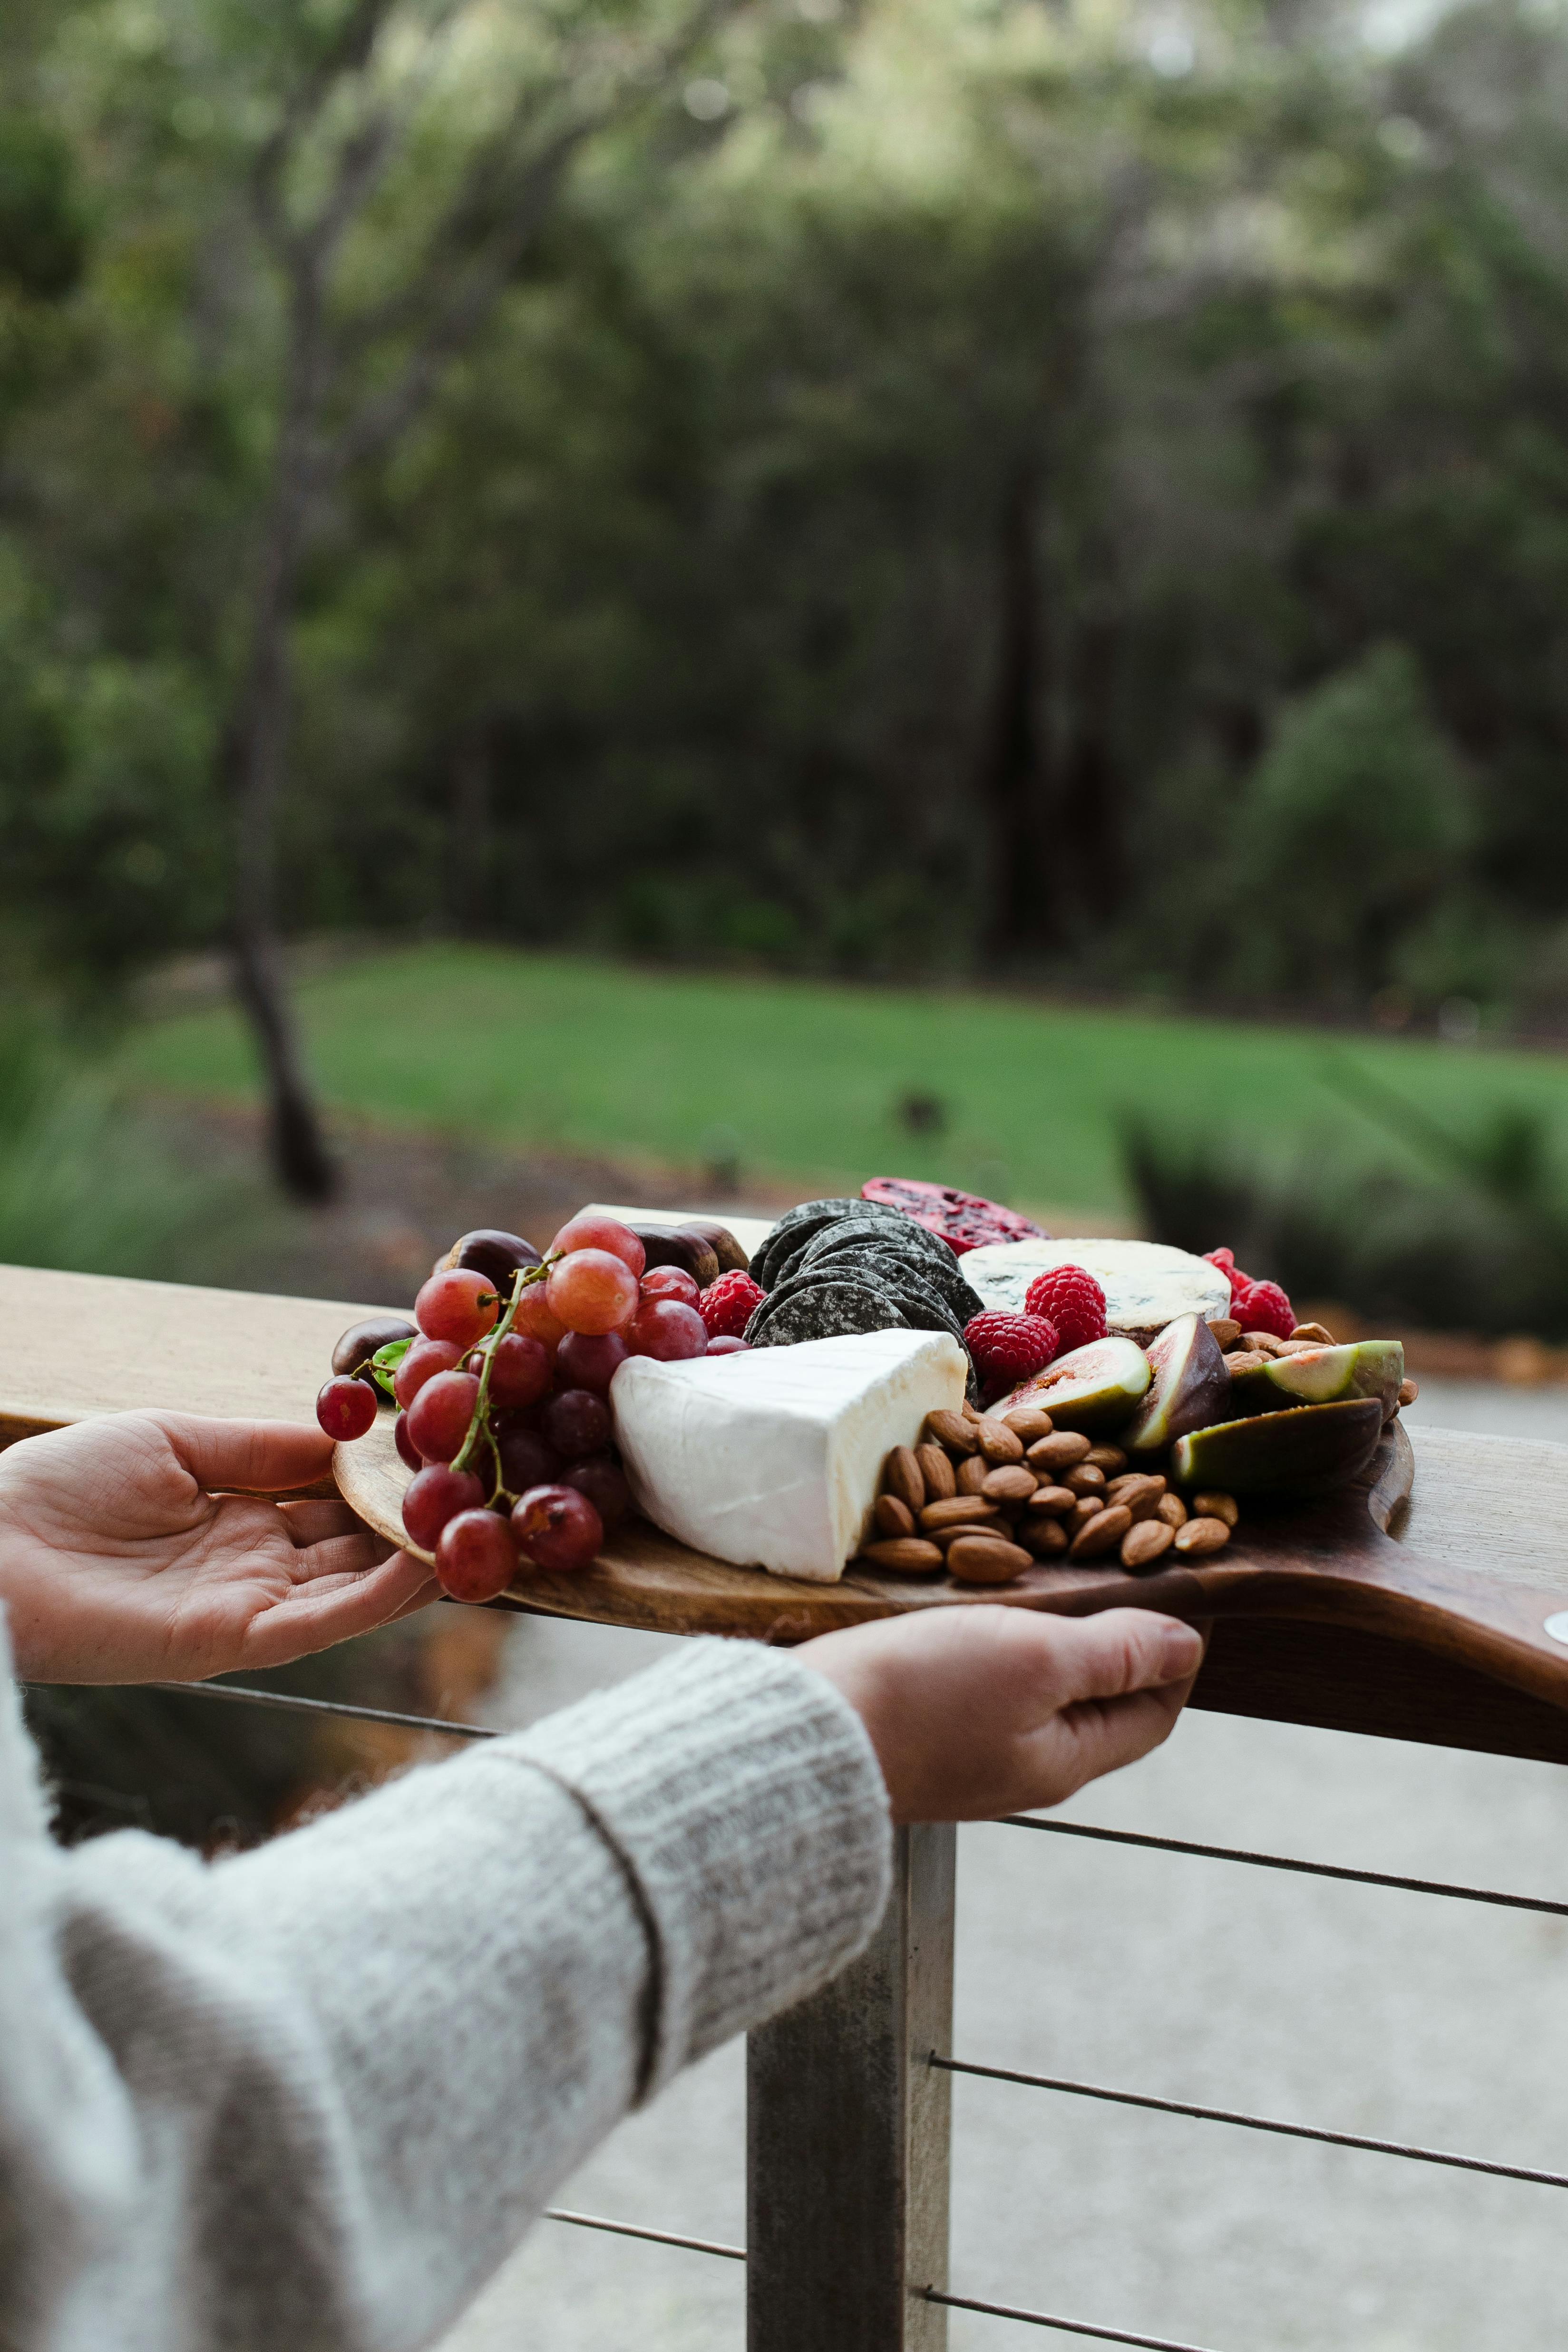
[609,1331,969,1585]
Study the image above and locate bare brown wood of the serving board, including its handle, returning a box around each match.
[334,1416,1568,1708]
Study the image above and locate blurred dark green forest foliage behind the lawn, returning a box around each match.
[0,0,1568,1028]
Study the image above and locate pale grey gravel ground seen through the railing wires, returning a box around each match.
[444,1381,1568,2352]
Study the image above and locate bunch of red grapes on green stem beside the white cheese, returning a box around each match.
[315,1214,740,1602]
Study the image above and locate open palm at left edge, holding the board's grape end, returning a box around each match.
[0,1414,439,1682]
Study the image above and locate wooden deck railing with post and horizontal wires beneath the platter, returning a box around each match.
[12,1268,1568,2352]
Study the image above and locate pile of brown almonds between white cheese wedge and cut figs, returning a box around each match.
[860,1404,1237,1585]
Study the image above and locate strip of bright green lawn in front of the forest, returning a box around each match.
[127,946,1568,1211]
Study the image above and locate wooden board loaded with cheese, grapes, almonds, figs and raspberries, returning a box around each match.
[317,1178,1568,1705]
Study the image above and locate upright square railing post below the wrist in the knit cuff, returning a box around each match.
[745,1827,954,2352]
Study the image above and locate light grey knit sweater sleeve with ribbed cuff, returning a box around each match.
[0,1642,891,2352]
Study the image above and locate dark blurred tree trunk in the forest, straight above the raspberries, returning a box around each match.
[978,463,1051,964]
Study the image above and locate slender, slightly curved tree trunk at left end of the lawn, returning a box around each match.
[226,470,339,1202]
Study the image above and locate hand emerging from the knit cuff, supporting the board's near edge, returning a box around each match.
[797,1604,1204,1823]
